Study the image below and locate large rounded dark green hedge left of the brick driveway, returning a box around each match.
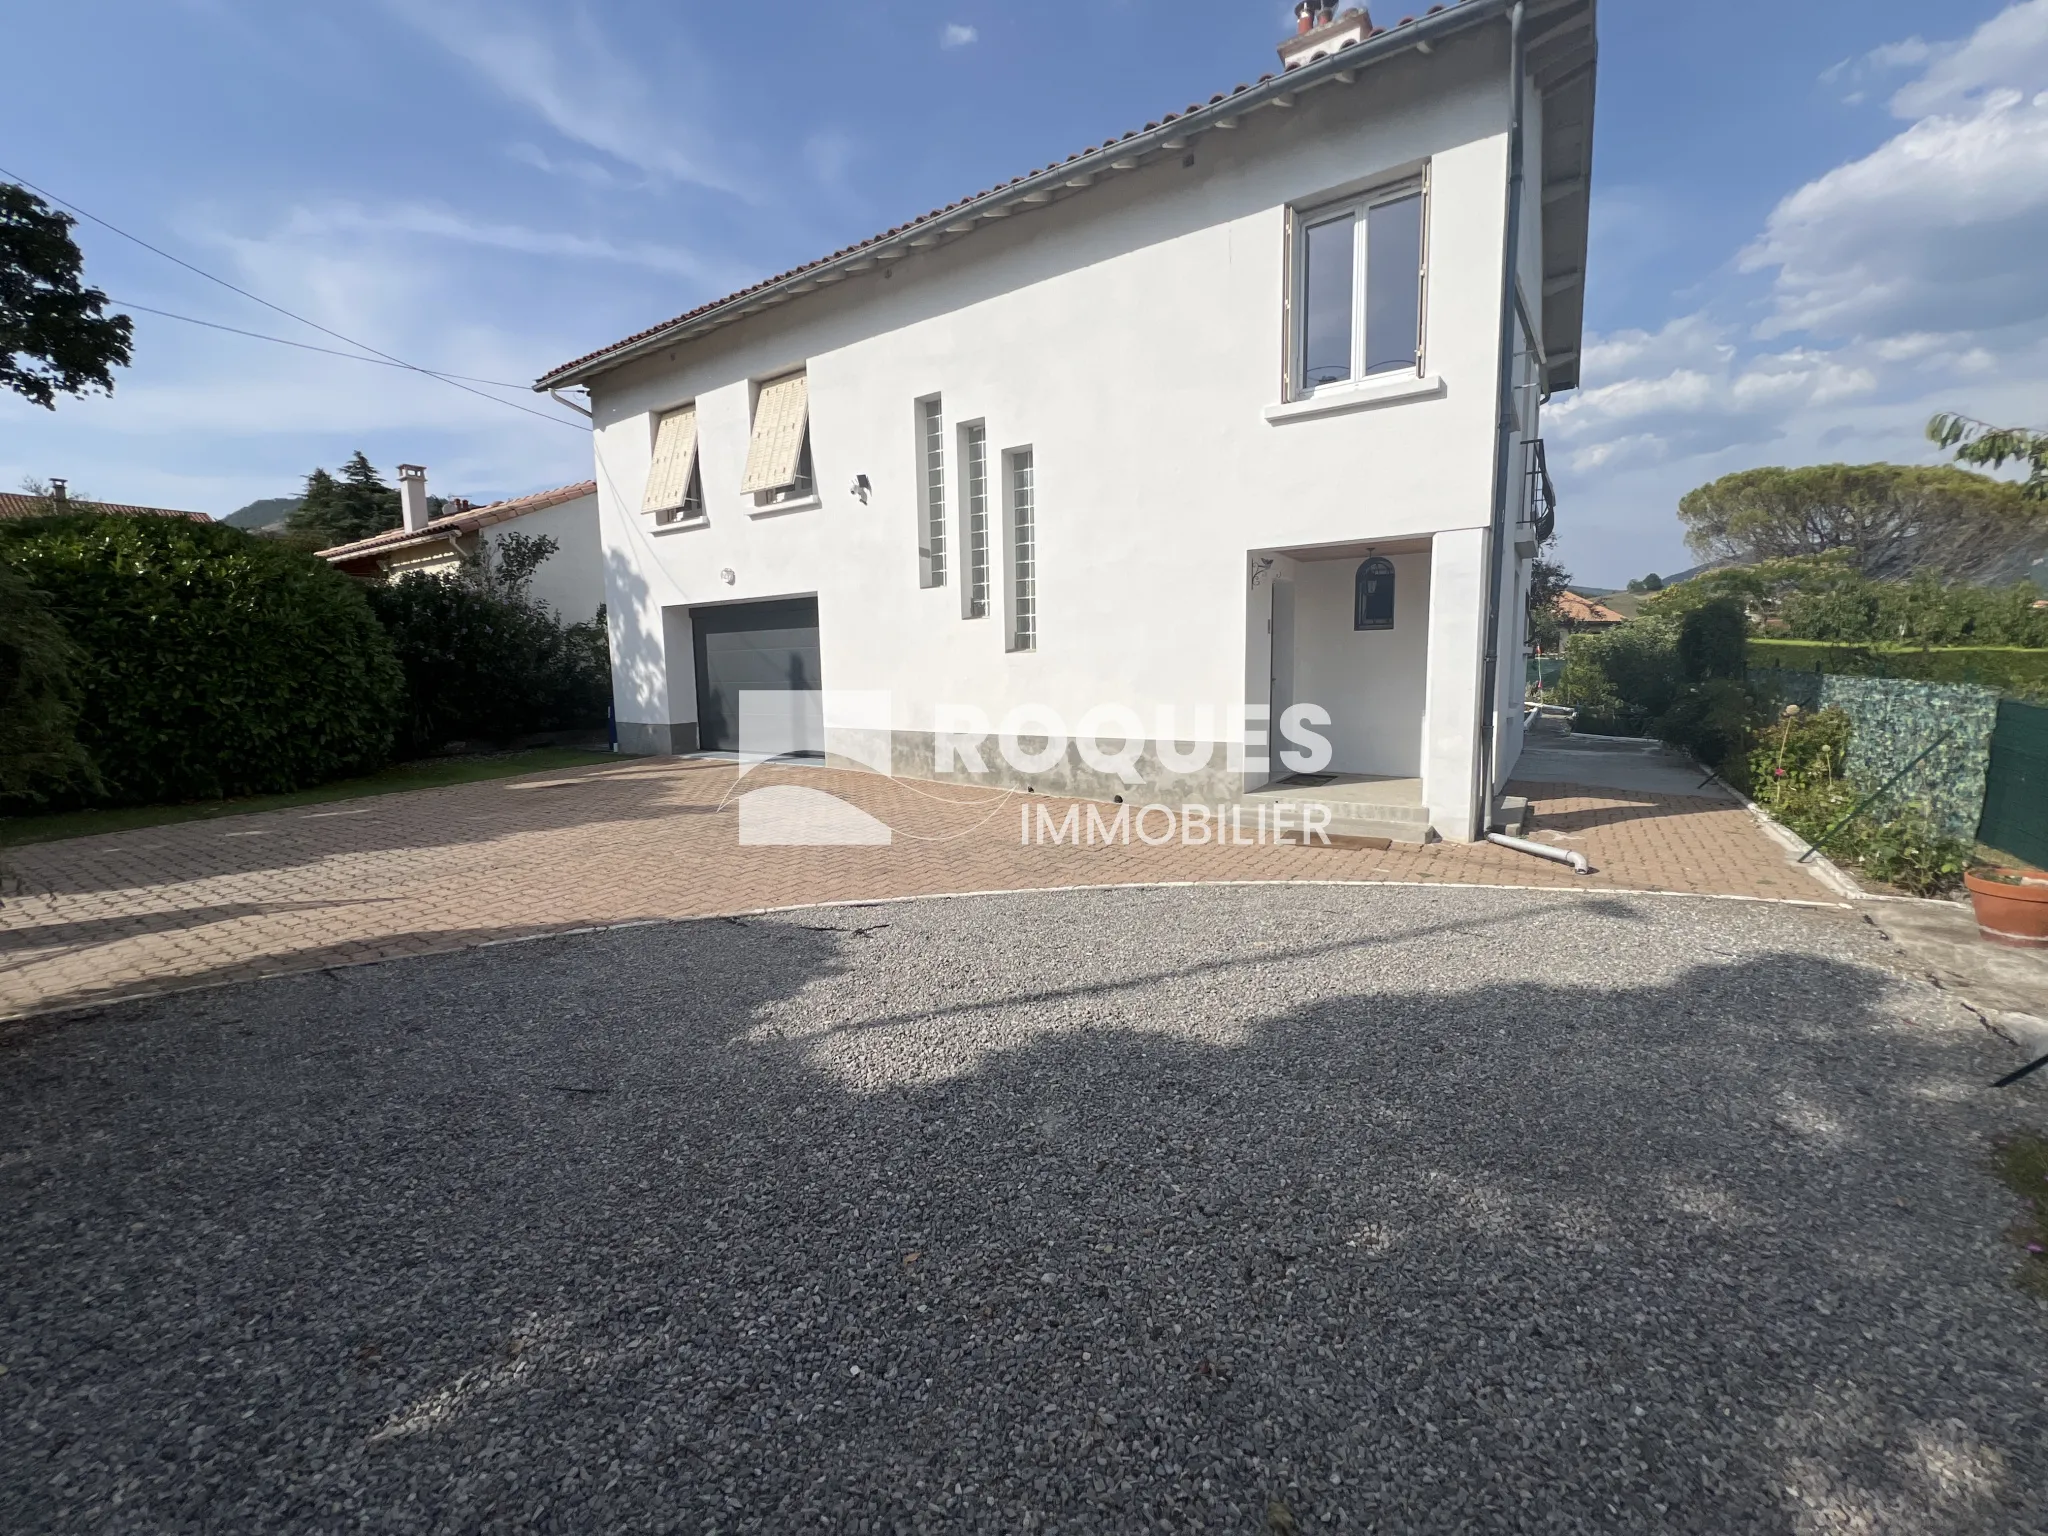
[0,516,401,805]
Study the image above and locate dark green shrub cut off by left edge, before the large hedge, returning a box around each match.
[0,565,96,805]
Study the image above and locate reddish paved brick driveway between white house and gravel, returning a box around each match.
[0,760,1831,1018]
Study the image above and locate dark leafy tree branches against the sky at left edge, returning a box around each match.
[0,182,135,410]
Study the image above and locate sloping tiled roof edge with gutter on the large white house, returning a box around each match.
[535,0,1591,391]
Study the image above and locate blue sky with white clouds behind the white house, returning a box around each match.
[0,0,2048,584]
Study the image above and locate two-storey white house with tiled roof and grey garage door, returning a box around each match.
[537,0,1597,838]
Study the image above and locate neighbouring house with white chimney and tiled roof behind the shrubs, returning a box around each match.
[319,465,604,625]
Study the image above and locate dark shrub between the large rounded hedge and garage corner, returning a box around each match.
[369,575,612,756]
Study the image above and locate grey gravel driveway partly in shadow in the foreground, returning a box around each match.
[0,887,2048,1532]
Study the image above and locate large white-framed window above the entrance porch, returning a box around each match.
[1292,182,1427,395]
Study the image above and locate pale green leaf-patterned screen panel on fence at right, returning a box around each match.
[1749,668,2019,852]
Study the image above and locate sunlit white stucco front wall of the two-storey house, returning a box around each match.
[592,35,1540,836]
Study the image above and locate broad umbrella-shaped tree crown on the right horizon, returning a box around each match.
[1677,465,2048,582]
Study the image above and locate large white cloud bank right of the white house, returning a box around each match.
[1546,0,2048,582]
